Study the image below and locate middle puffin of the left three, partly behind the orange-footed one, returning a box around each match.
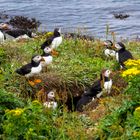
[41,47,53,67]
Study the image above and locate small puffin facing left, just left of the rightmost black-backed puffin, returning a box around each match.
[104,40,116,57]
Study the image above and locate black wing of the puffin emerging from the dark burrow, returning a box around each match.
[84,80,102,97]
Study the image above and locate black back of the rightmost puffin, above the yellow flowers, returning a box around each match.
[118,49,133,67]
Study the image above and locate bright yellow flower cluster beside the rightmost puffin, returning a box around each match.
[122,59,140,77]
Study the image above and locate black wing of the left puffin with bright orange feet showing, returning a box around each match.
[16,64,32,75]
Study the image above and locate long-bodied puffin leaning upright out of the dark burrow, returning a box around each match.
[76,69,112,112]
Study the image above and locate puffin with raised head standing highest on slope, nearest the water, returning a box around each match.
[41,28,62,49]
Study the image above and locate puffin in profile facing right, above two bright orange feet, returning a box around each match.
[15,55,44,78]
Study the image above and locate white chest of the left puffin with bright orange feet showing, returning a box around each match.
[25,64,42,77]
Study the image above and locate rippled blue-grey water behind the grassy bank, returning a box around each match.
[0,0,140,37]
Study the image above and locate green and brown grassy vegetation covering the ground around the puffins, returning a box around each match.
[0,33,140,140]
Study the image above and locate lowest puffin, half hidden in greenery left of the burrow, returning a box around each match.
[43,91,58,109]
